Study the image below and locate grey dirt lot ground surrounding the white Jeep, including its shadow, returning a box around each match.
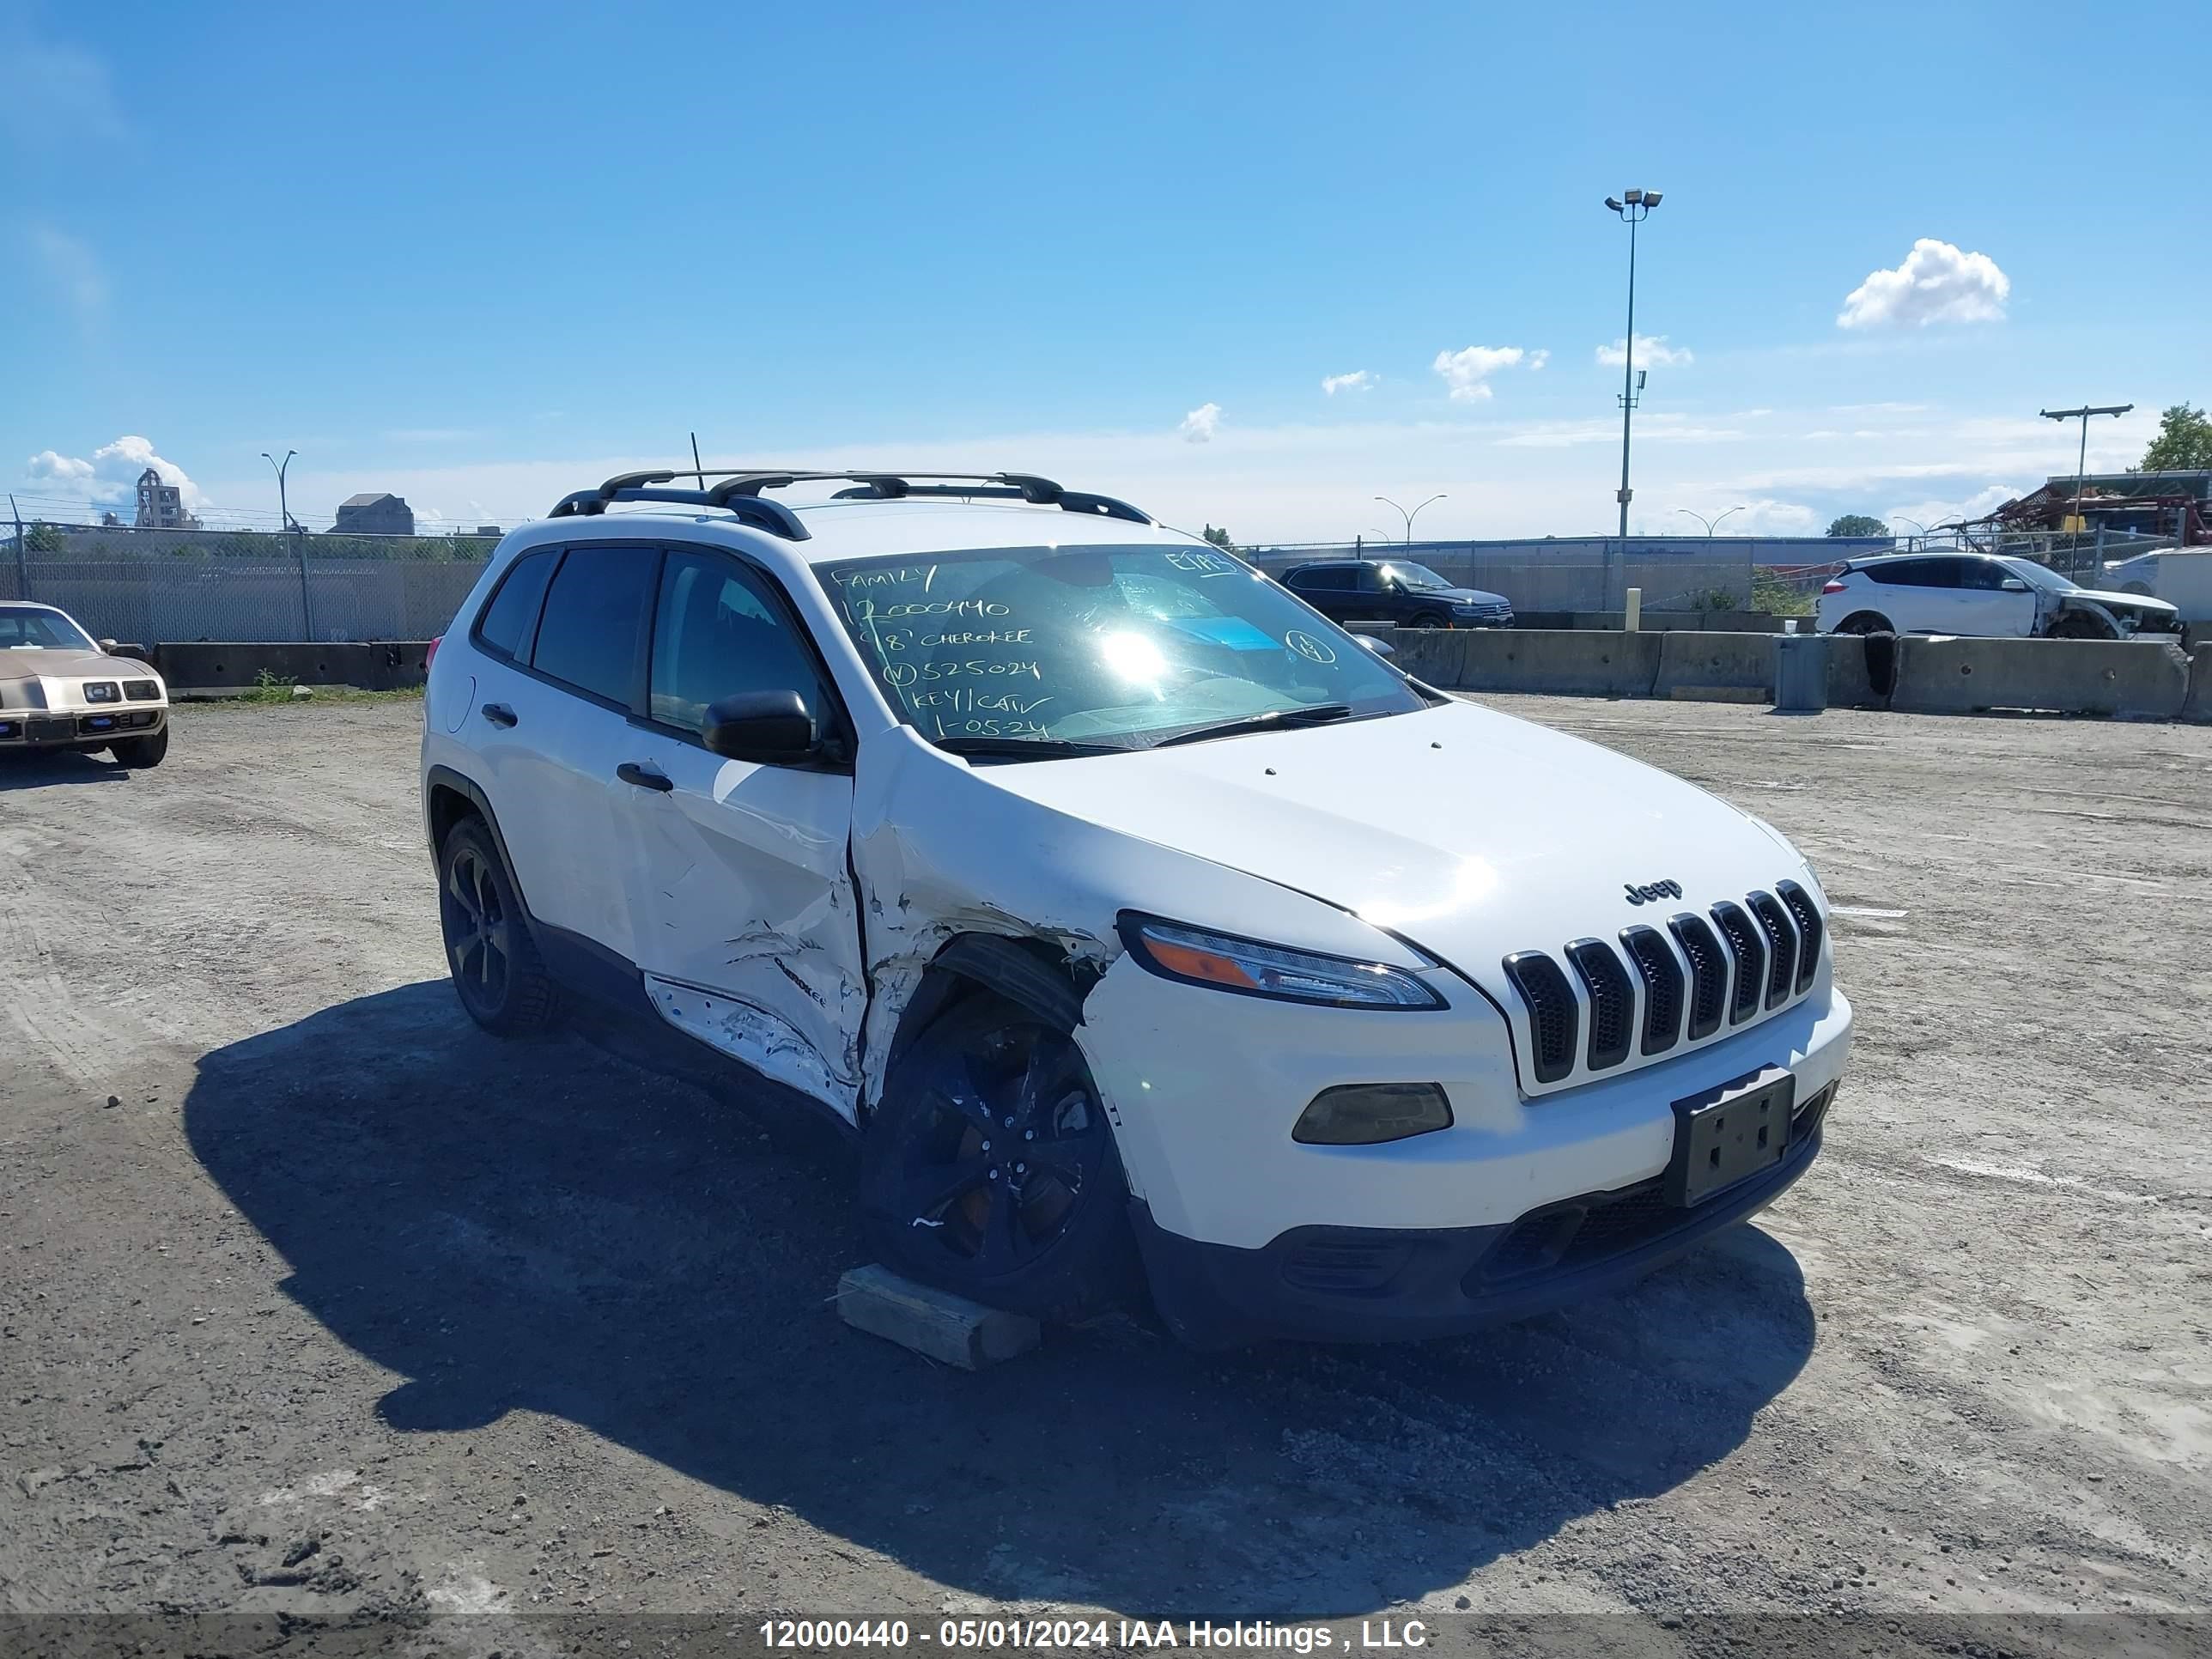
[0,699,2212,1645]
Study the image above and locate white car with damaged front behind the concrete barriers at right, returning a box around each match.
[1816,553,2181,639]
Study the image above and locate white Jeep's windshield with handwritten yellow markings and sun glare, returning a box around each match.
[814,546,1425,757]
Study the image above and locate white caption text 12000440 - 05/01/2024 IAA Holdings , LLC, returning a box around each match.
[761,1620,1429,1652]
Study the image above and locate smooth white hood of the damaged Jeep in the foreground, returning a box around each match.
[978,702,1814,1000]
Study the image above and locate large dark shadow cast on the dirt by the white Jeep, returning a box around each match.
[184,982,1814,1620]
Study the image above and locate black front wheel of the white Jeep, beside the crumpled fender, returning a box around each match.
[860,991,1139,1322]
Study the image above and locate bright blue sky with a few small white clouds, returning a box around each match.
[0,0,2212,540]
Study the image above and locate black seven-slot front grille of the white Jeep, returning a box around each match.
[1504,880,1825,1084]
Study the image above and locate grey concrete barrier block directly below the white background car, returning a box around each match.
[1889,635,2190,719]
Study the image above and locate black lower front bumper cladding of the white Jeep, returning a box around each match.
[1130,1086,1836,1343]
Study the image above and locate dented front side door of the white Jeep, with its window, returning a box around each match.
[626,549,867,1117]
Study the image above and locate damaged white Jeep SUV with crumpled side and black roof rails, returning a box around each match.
[422,471,1851,1345]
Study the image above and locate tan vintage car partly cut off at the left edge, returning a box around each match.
[0,599,168,768]
